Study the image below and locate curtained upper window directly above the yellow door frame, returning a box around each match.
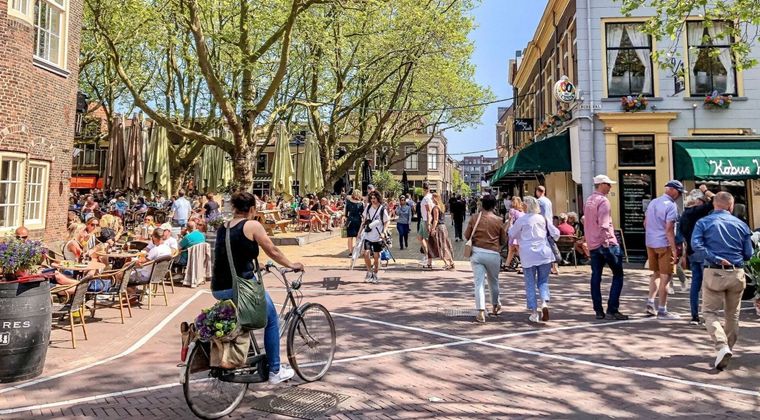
[606,23,653,97]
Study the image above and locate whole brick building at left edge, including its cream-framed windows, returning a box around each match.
[0,0,83,241]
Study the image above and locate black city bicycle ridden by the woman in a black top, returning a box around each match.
[179,261,336,419]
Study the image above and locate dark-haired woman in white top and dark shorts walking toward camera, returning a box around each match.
[362,191,390,283]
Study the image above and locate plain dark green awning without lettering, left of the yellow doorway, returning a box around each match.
[491,131,572,184]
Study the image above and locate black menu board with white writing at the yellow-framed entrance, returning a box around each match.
[620,170,655,253]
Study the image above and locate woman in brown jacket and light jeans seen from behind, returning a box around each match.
[464,195,507,323]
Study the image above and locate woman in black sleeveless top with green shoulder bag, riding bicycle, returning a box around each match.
[211,192,303,384]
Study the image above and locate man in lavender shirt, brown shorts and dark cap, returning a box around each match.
[644,180,684,320]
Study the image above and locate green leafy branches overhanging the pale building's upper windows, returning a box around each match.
[617,0,760,70]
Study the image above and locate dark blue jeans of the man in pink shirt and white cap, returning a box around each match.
[591,245,623,314]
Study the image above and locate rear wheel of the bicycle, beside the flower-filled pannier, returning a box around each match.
[182,342,248,419]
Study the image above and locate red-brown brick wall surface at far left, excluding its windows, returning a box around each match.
[0,0,83,241]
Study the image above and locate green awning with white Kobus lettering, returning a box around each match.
[673,140,760,180]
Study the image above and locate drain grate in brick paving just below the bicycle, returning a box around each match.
[252,388,348,419]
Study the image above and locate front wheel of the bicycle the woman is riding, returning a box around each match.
[288,303,335,382]
